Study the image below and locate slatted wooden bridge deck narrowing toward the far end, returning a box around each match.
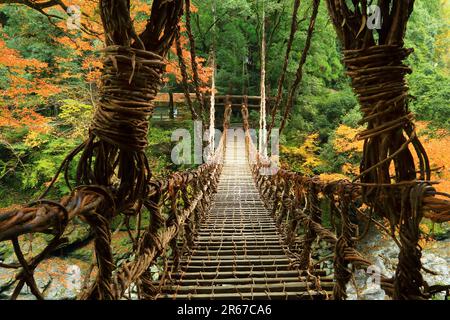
[158,135,333,299]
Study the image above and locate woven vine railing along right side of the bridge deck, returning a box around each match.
[242,104,450,300]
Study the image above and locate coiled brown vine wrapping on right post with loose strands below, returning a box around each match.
[344,45,430,225]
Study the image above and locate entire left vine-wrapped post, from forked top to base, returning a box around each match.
[72,0,182,299]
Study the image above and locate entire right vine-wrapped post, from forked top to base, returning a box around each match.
[327,0,430,299]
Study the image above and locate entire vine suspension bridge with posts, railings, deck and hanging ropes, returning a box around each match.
[0,0,450,300]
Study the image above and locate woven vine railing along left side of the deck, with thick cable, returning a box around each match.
[0,133,226,299]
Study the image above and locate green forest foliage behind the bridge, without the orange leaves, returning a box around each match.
[0,0,450,204]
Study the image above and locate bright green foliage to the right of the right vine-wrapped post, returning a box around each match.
[406,0,450,129]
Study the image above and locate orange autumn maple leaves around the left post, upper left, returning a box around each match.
[0,0,212,136]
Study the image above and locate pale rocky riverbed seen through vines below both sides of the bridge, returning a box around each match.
[0,225,450,300]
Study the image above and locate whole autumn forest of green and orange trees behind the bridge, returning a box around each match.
[0,0,450,300]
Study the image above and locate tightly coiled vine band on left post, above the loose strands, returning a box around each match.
[91,46,165,152]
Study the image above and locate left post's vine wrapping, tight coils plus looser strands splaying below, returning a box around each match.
[77,45,164,213]
